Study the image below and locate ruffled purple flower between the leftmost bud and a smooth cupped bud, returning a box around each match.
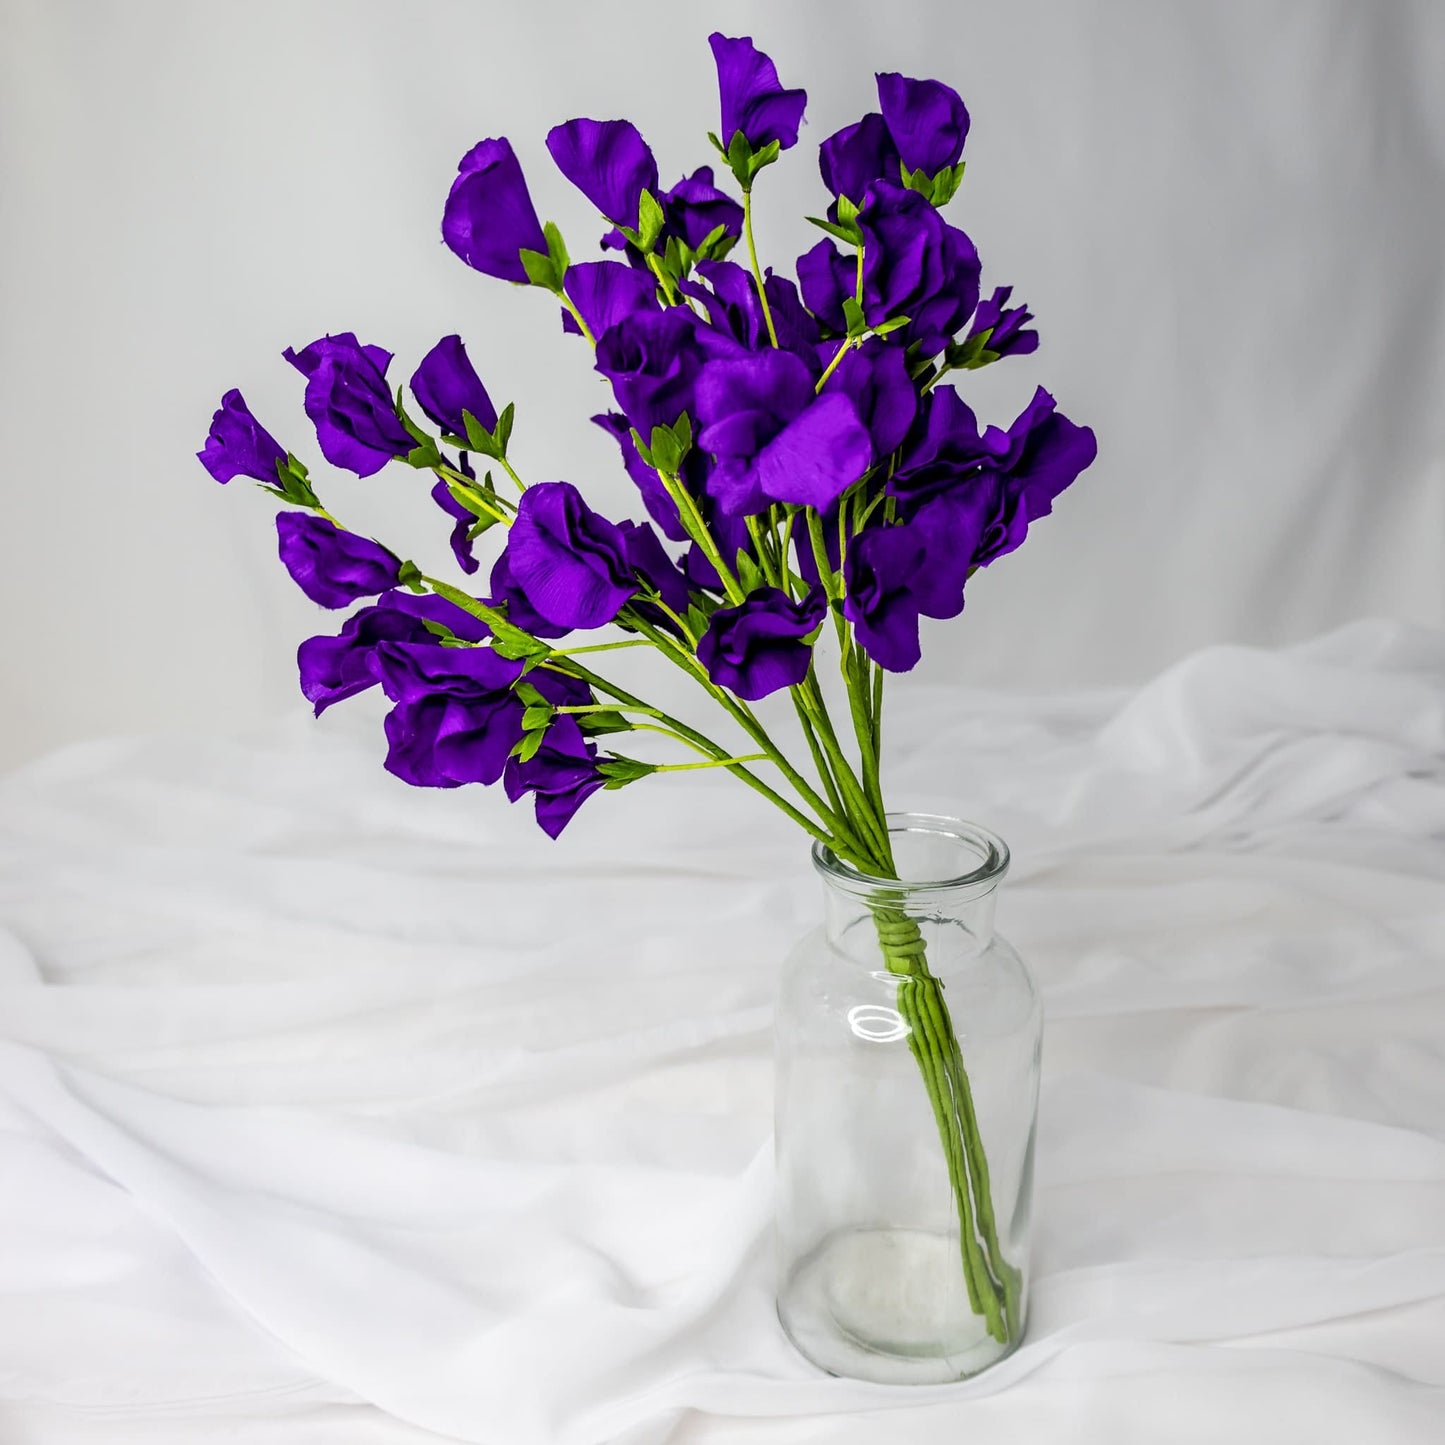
[282,331,416,477]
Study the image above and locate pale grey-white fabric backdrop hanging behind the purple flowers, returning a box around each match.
[0,0,1445,767]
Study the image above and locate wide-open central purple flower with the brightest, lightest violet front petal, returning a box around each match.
[696,351,873,516]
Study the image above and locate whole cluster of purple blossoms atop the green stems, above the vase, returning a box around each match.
[199,35,1095,835]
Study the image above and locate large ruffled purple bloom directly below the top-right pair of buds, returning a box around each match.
[858,181,980,357]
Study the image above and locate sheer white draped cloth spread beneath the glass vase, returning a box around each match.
[0,623,1445,1445]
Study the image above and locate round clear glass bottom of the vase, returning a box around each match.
[777,1228,1017,1384]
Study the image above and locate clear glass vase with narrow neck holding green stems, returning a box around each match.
[776,814,1043,1384]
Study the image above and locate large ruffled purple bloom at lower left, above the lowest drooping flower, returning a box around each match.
[376,642,525,788]
